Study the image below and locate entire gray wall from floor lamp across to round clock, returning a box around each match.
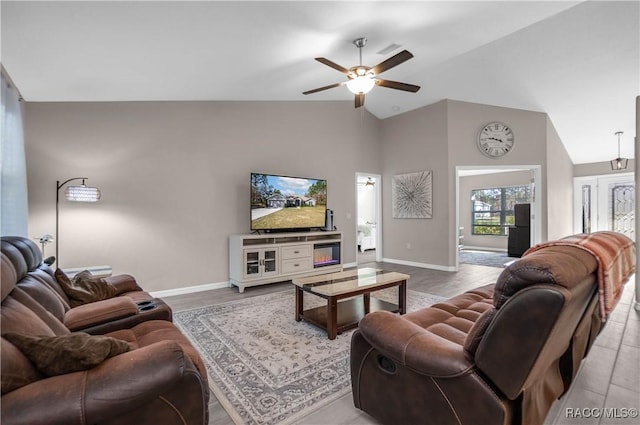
[26,100,571,291]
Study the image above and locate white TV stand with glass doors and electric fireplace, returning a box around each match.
[229,231,342,292]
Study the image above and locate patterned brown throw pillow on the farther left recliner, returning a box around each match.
[55,269,116,308]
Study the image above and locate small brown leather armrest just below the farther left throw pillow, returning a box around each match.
[63,297,138,331]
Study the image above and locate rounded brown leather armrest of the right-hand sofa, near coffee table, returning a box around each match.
[358,311,473,377]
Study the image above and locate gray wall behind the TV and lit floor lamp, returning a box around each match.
[26,102,382,291]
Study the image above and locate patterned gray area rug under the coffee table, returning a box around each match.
[173,288,444,425]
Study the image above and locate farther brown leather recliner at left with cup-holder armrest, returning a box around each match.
[0,236,173,334]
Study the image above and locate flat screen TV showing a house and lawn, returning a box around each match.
[251,173,327,232]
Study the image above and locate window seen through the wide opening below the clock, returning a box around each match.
[471,186,531,236]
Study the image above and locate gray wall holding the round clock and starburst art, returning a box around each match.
[381,100,571,270]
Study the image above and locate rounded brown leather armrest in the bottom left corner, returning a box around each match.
[2,341,194,425]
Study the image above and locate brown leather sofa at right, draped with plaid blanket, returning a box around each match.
[351,234,635,425]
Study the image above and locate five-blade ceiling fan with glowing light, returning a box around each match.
[302,37,420,108]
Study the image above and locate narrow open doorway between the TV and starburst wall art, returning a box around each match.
[355,172,382,265]
